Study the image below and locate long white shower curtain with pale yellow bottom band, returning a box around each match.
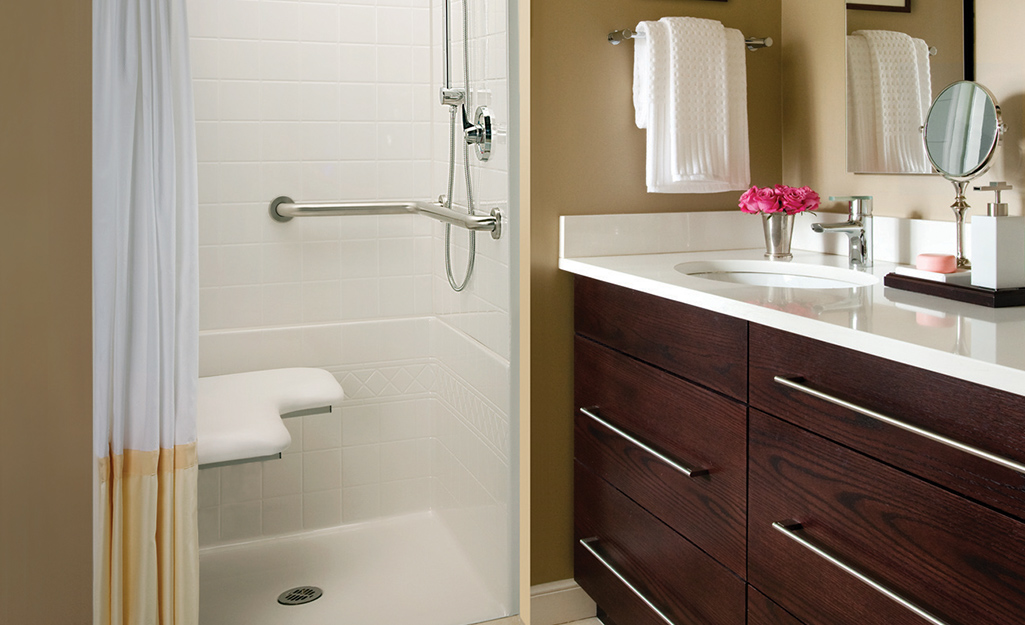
[93,0,199,625]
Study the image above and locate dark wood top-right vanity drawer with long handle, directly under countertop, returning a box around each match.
[750,324,1025,519]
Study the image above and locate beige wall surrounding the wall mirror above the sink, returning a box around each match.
[782,0,1025,219]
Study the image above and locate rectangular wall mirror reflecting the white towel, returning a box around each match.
[846,0,975,174]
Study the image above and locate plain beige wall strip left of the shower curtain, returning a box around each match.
[0,0,92,625]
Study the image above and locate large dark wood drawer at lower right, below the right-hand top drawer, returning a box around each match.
[748,410,1025,625]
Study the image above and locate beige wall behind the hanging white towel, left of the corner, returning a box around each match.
[530,0,781,584]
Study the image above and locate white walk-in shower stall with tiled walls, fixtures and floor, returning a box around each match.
[189,0,518,625]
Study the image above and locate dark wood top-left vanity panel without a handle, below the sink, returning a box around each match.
[575,277,747,401]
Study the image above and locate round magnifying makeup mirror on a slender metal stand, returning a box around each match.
[923,80,1005,268]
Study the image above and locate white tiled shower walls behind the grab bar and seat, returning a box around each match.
[189,7,516,610]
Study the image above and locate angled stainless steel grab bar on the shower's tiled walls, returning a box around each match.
[271,196,502,239]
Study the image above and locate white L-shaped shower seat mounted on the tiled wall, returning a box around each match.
[196,368,342,467]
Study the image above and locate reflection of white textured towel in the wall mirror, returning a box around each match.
[849,31,932,173]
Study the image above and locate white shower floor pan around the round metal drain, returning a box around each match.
[200,512,505,625]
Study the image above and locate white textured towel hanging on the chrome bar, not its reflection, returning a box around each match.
[633,17,750,193]
